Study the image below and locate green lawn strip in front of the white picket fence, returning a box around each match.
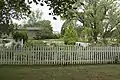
[0,65,120,80]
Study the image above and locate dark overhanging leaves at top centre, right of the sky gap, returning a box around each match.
[28,0,77,20]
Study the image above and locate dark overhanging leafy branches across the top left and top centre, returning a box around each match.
[0,0,83,21]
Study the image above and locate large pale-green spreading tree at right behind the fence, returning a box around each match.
[84,0,120,42]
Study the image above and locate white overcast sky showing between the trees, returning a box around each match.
[13,3,64,32]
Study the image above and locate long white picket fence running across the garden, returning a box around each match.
[0,46,120,65]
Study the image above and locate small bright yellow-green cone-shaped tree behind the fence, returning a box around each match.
[63,26,78,45]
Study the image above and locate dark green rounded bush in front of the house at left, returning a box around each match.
[13,32,28,44]
